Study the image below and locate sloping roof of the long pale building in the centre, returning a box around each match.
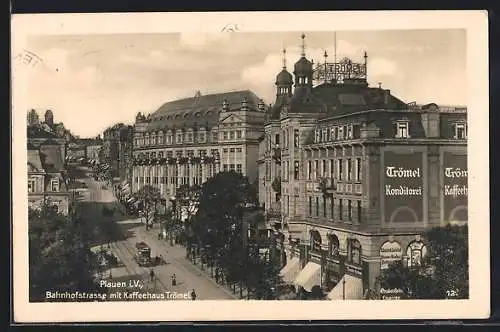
[147,90,260,130]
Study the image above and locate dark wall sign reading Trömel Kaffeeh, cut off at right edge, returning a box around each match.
[442,152,468,221]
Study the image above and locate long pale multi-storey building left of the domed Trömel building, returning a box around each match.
[131,91,265,200]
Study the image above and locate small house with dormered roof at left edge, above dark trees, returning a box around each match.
[27,143,70,214]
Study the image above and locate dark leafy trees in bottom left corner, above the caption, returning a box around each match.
[28,201,99,302]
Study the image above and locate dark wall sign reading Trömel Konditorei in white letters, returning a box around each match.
[383,151,424,223]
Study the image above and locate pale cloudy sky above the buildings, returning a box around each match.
[19,29,467,137]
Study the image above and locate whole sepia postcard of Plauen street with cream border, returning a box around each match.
[12,11,490,322]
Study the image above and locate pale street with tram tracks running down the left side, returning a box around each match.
[76,166,237,300]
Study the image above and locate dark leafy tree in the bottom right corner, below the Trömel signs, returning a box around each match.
[379,225,469,299]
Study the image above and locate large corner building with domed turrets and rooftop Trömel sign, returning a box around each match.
[259,35,467,299]
